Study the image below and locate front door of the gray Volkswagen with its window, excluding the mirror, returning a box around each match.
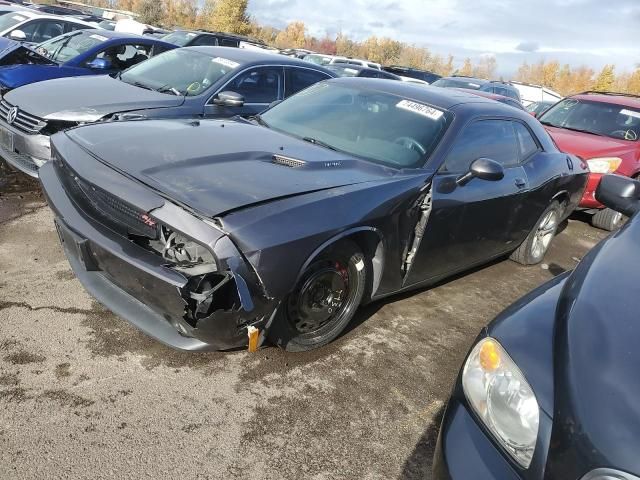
[205,66,284,117]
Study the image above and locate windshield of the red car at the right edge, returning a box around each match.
[540,98,640,141]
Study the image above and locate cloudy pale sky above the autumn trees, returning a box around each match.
[249,0,640,76]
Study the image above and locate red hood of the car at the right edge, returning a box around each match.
[544,125,638,160]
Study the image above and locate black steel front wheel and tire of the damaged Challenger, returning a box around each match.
[268,240,368,352]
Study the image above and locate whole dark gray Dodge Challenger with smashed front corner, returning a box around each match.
[40,78,587,351]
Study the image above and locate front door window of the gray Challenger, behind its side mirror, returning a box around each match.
[444,120,519,173]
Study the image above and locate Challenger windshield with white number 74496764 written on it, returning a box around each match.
[260,83,451,168]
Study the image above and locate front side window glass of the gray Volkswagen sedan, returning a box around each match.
[222,67,283,104]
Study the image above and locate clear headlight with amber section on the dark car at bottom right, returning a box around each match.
[462,337,540,468]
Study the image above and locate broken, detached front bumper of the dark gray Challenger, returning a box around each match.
[40,162,276,351]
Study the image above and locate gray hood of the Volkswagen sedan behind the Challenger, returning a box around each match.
[4,75,184,122]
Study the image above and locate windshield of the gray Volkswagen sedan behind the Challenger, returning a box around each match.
[120,49,240,96]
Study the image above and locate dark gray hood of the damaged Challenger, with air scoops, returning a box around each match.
[66,120,396,217]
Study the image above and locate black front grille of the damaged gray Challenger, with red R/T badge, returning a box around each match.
[55,158,158,239]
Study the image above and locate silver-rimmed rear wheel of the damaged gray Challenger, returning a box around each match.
[509,202,562,265]
